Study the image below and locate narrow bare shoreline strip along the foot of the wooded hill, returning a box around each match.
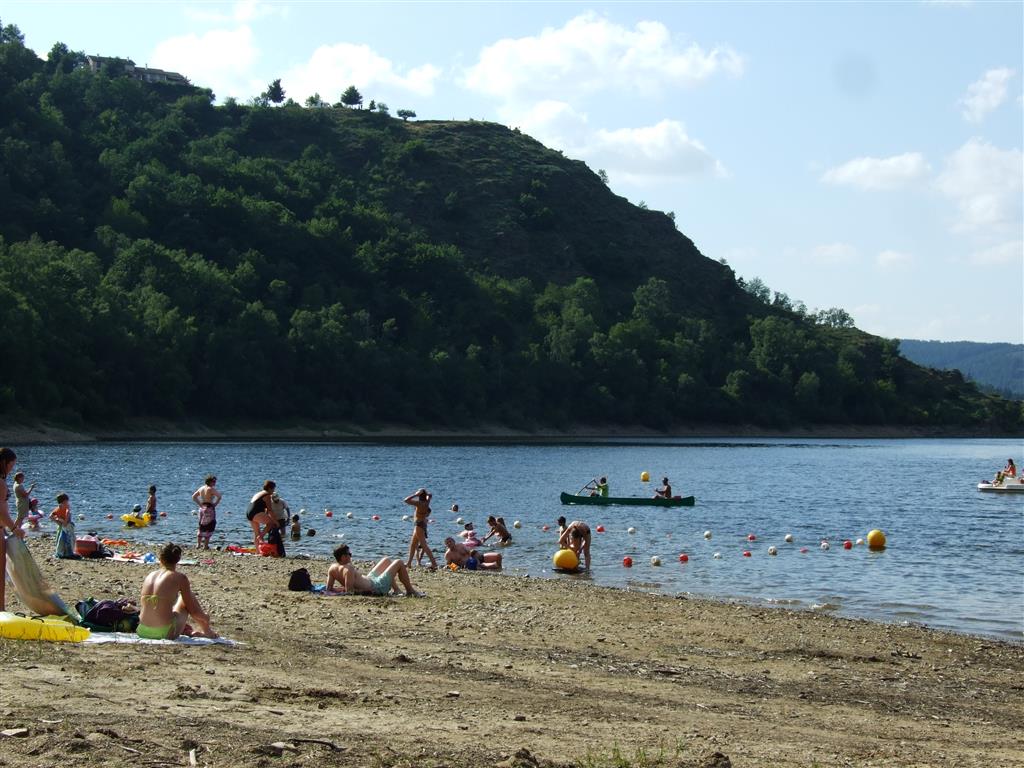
[0,420,1024,445]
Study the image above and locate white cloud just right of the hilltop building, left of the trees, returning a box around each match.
[148,25,266,101]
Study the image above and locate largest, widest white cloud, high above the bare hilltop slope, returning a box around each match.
[463,12,743,101]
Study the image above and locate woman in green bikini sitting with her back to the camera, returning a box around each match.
[135,544,217,640]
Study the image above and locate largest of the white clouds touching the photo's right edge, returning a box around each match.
[936,138,1024,232]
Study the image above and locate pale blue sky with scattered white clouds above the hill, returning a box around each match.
[8,0,1024,343]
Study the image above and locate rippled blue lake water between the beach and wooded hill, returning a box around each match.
[14,438,1024,642]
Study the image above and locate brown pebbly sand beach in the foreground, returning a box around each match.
[0,540,1024,768]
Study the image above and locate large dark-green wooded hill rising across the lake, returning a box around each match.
[0,26,1021,430]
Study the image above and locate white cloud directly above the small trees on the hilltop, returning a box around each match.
[281,43,441,108]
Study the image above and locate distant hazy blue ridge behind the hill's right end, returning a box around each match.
[899,339,1024,399]
